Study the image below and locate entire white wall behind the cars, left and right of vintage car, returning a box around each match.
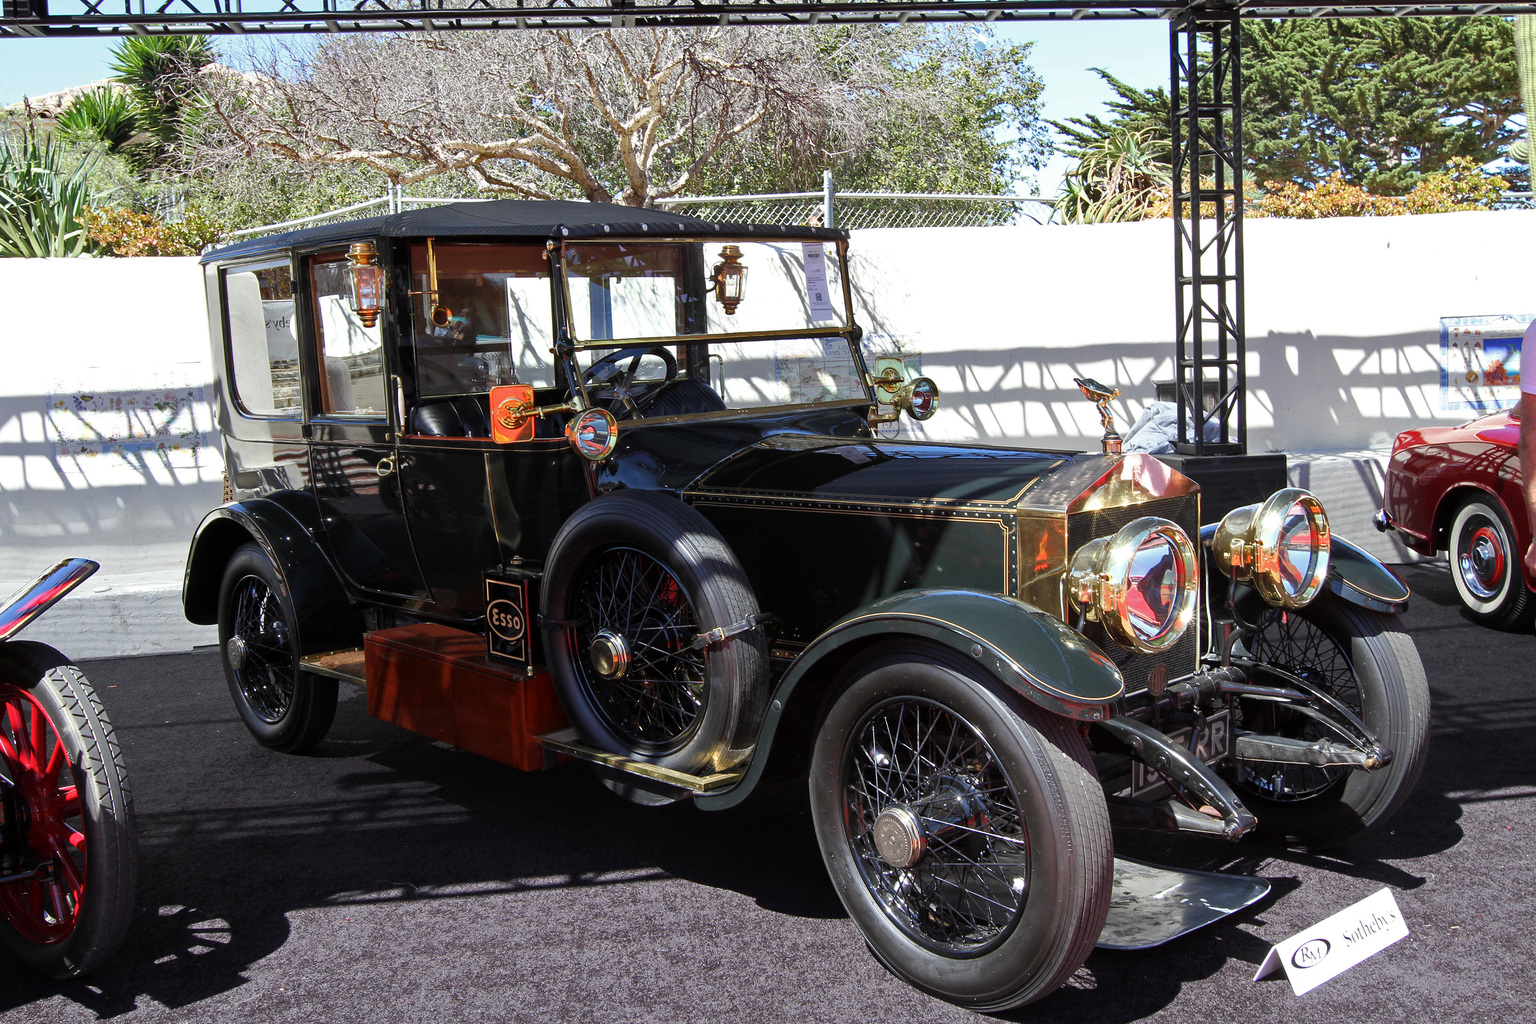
[0,210,1536,657]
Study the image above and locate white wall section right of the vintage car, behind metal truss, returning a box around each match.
[852,210,1536,451]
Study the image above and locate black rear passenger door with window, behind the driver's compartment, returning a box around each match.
[303,250,430,600]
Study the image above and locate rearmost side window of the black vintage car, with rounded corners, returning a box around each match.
[224,259,300,416]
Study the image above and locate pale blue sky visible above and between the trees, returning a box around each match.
[0,18,1167,195]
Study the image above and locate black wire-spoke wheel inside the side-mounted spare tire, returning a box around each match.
[571,547,708,755]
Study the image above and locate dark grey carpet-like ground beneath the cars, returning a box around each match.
[0,567,1536,1024]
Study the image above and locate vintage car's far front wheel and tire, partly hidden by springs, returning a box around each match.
[1236,593,1430,847]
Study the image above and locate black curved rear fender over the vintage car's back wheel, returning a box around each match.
[181,497,362,654]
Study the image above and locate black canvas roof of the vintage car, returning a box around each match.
[203,200,848,263]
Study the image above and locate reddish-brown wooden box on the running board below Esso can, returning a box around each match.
[362,623,567,771]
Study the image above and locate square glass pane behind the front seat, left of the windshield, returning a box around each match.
[410,241,554,398]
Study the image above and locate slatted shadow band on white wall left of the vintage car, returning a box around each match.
[0,388,223,548]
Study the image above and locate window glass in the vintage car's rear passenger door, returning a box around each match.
[309,255,386,416]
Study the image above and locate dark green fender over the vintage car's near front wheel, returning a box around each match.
[694,590,1126,809]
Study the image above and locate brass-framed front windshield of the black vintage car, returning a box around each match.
[564,241,868,416]
